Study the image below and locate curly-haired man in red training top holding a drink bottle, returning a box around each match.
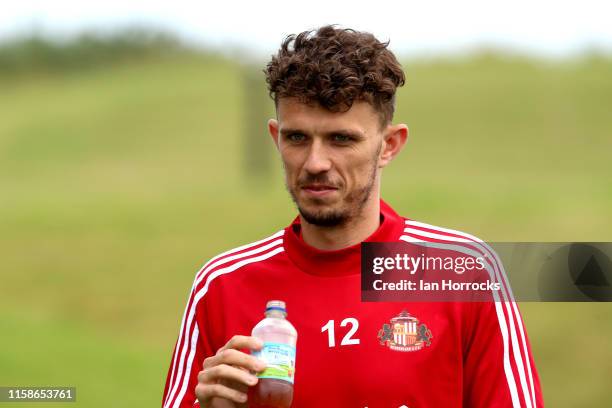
[163,26,543,408]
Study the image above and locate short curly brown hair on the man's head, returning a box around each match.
[264,25,405,126]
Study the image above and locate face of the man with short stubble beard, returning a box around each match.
[268,98,402,227]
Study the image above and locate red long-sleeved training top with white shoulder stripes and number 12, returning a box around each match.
[163,200,543,408]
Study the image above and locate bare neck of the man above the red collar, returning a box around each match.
[300,193,380,251]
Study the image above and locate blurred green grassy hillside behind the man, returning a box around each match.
[0,33,612,407]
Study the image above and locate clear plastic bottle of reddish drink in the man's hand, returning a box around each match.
[249,300,297,408]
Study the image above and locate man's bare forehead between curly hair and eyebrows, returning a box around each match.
[276,98,380,134]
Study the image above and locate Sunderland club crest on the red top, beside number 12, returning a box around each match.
[378,310,433,351]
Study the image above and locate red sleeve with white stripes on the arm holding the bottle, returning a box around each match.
[162,280,214,408]
